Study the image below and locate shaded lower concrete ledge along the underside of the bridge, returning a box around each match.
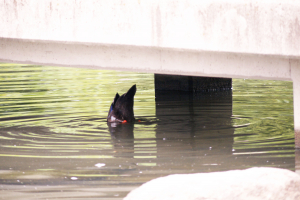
[0,38,291,80]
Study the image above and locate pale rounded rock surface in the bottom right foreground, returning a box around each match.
[124,168,300,200]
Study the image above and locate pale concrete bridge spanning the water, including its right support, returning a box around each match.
[0,0,300,148]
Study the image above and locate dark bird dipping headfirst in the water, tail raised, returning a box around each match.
[107,85,136,123]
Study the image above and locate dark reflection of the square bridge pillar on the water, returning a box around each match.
[156,91,234,173]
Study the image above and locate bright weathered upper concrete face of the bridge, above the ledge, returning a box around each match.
[0,0,300,57]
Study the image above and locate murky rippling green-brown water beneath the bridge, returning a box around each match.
[0,64,295,199]
